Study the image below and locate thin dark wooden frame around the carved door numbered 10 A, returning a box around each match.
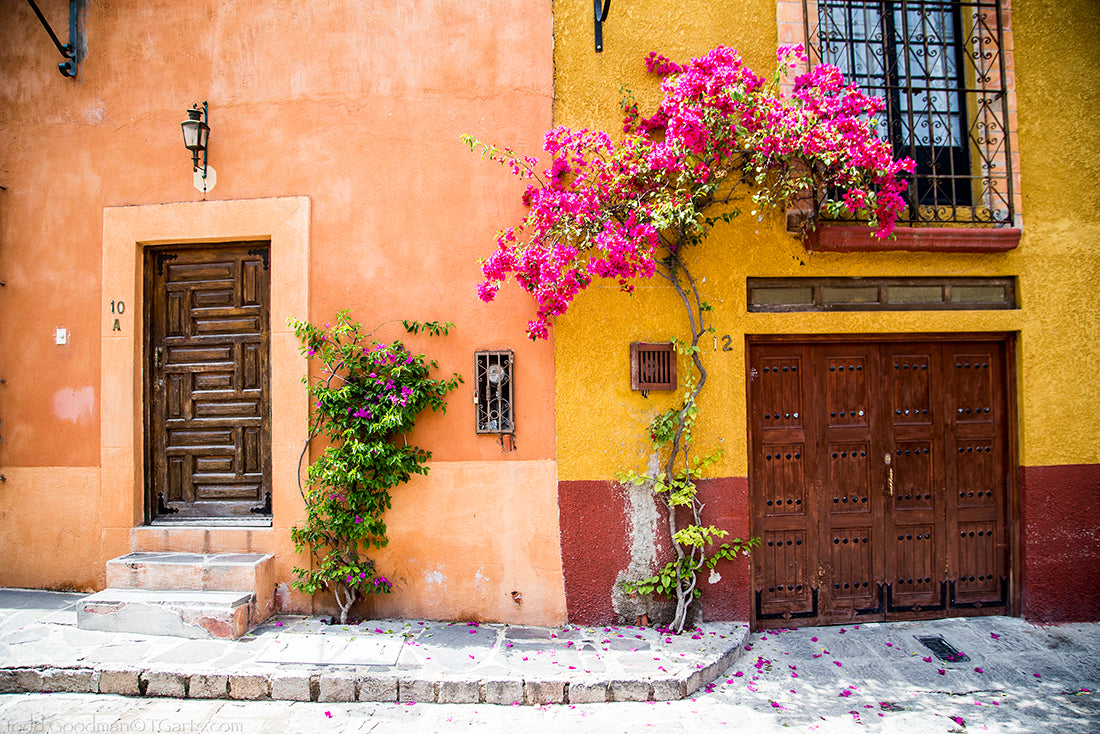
[141,240,272,525]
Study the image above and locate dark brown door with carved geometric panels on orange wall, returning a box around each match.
[145,243,271,521]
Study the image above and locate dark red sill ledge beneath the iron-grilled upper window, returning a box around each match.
[803,224,1020,253]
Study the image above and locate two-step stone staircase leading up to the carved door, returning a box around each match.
[77,552,275,639]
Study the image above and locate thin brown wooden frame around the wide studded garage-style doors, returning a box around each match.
[745,331,1022,629]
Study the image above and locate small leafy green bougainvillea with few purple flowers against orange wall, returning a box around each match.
[289,310,462,624]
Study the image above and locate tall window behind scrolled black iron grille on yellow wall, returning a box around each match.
[803,0,1013,226]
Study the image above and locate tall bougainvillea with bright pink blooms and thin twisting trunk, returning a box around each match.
[464,46,914,632]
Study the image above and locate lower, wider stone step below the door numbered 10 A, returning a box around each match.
[76,589,260,639]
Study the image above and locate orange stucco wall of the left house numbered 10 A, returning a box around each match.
[0,0,564,623]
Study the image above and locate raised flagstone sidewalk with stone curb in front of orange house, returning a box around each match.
[0,589,747,704]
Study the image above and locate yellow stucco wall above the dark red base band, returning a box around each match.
[554,0,1100,480]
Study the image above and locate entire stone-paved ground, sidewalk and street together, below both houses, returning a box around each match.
[0,592,1100,734]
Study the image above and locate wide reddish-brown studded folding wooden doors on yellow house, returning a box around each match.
[748,337,1012,627]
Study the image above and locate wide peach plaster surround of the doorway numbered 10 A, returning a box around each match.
[98,196,310,537]
